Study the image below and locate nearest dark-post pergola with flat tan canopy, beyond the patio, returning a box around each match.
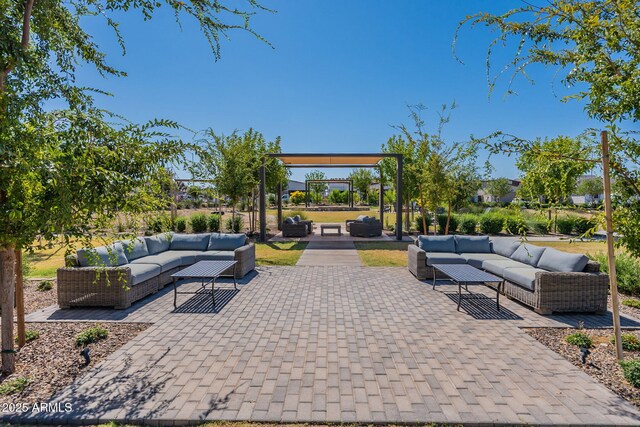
[260,153,402,242]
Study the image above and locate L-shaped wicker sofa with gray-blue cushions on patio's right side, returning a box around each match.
[408,236,609,314]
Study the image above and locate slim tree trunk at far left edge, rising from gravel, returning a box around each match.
[0,246,16,374]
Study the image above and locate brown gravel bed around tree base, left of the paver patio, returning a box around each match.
[0,322,149,407]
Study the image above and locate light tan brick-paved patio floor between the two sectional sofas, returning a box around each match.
[16,267,640,425]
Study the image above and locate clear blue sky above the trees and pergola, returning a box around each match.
[80,0,597,179]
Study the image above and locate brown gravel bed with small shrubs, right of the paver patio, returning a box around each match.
[524,328,640,408]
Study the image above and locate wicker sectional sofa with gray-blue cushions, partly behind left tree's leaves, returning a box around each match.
[57,233,256,309]
